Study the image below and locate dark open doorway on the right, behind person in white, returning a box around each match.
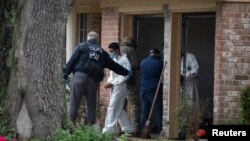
[182,13,215,119]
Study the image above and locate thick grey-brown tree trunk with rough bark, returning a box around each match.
[5,0,73,140]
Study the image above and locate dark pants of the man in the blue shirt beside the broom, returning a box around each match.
[141,88,163,133]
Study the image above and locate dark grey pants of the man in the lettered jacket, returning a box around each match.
[69,72,99,125]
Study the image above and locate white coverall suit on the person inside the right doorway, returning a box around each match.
[181,52,199,107]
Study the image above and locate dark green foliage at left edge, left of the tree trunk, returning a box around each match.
[0,0,17,138]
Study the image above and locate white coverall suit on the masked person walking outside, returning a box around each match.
[102,56,134,133]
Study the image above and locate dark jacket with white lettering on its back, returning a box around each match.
[63,40,129,78]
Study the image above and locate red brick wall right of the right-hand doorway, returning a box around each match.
[214,3,250,124]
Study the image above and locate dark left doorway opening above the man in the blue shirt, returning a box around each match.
[133,15,164,60]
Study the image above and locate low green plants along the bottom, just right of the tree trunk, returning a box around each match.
[52,126,112,141]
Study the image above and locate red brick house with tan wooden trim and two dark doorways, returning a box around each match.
[66,0,250,137]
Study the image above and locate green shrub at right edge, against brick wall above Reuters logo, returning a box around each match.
[240,86,250,124]
